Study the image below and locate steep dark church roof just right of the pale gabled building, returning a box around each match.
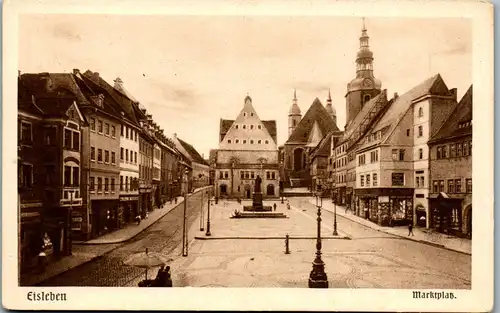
[286,98,339,144]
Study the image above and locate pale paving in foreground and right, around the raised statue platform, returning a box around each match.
[149,198,471,289]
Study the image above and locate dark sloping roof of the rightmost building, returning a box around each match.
[429,85,473,143]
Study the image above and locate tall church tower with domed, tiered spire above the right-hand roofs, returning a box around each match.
[345,18,382,126]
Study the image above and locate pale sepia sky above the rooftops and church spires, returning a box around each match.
[18,14,472,158]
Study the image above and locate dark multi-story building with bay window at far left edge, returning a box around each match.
[18,73,87,268]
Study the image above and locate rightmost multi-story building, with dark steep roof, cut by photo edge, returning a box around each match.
[430,86,473,238]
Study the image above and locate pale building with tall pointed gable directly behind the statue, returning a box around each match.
[214,96,279,199]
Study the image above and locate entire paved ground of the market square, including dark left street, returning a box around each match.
[37,196,471,289]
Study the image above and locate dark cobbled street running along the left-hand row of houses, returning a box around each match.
[38,190,206,287]
